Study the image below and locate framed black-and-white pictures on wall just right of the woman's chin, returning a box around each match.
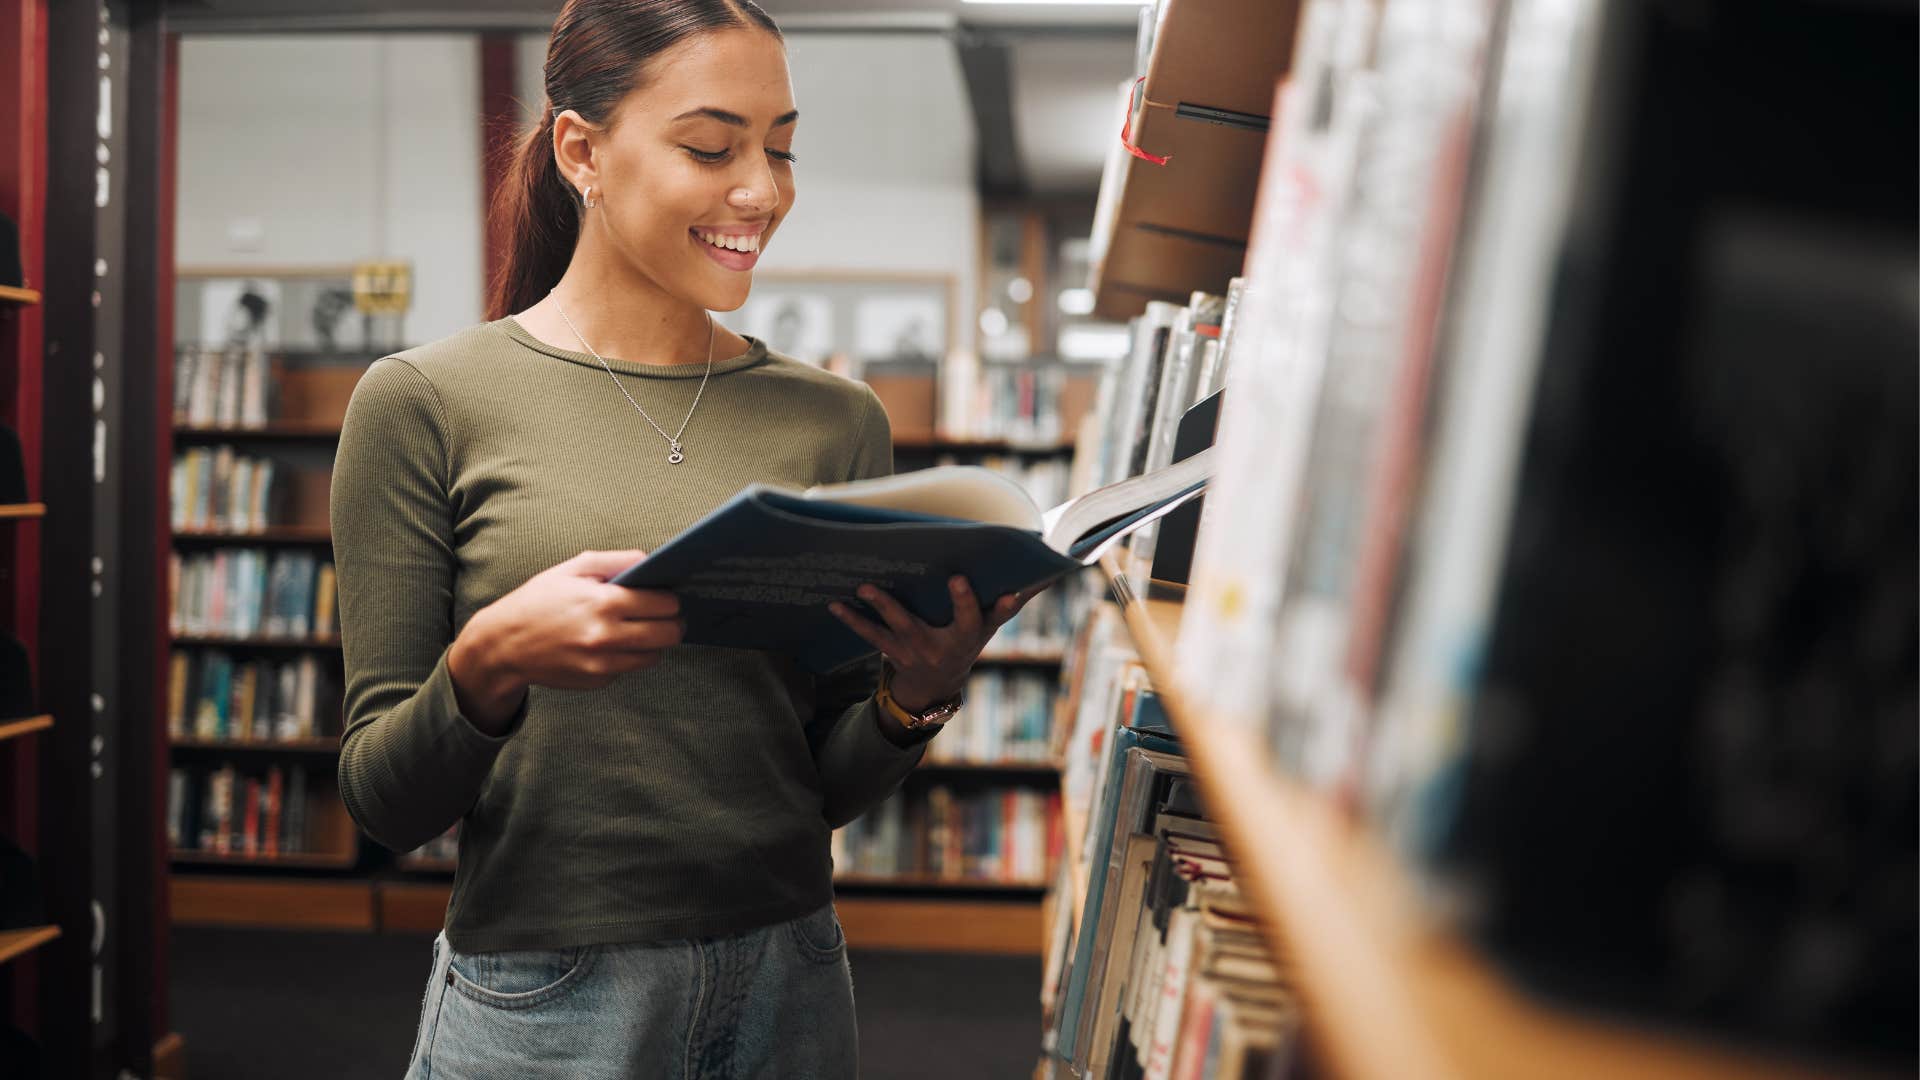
[718,271,954,377]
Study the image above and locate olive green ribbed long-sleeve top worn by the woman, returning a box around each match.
[332,319,922,951]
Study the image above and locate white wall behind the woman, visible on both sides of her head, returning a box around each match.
[177,33,979,348]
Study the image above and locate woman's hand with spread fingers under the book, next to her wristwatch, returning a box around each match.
[828,577,1035,713]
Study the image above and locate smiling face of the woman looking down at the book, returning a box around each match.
[584,29,797,311]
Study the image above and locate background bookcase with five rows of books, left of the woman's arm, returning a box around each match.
[167,344,364,903]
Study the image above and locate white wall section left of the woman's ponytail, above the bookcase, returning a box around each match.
[175,35,482,342]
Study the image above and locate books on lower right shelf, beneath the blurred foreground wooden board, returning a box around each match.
[1043,603,1302,1080]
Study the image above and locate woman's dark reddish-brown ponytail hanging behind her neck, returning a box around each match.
[486,102,580,319]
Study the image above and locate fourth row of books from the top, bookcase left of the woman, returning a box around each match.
[167,650,340,742]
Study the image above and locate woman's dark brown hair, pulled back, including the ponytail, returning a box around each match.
[486,0,781,319]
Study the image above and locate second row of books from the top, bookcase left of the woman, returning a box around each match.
[171,444,332,532]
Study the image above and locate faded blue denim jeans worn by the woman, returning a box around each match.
[407,903,858,1080]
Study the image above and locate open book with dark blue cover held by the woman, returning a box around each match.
[612,443,1213,673]
